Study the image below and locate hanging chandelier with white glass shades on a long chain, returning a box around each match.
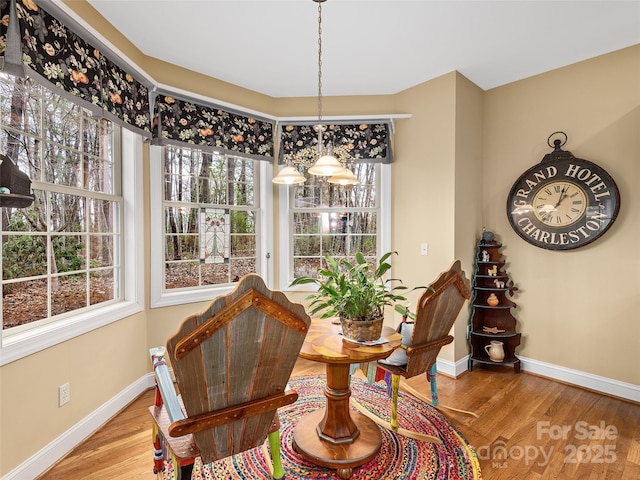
[273,0,360,185]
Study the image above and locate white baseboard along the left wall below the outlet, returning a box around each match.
[2,373,155,480]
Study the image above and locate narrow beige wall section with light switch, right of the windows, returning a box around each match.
[391,73,465,360]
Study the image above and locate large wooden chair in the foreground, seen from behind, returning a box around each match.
[149,274,311,479]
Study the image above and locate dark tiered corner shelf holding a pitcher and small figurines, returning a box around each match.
[468,232,521,372]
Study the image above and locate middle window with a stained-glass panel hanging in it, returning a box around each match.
[152,146,271,306]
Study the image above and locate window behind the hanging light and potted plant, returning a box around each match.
[280,163,390,289]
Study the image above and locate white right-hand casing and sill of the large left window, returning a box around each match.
[0,129,144,366]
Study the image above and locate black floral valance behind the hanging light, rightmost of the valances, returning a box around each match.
[280,123,392,163]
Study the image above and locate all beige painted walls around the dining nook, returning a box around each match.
[0,2,640,476]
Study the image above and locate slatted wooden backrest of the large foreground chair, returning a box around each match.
[167,274,311,462]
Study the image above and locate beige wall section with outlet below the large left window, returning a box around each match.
[0,314,149,475]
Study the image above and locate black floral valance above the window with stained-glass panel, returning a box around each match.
[153,95,273,160]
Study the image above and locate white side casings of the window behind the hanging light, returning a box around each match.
[278,163,391,292]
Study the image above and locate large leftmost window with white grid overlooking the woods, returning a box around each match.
[0,76,139,362]
